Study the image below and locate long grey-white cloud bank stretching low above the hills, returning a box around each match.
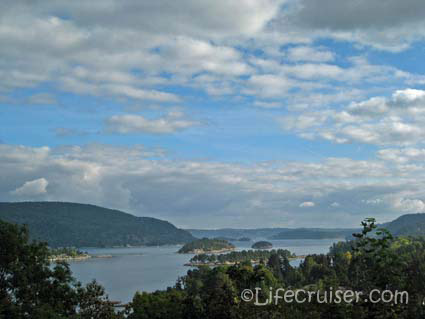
[0,144,425,227]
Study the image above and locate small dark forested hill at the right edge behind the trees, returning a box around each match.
[381,214,425,236]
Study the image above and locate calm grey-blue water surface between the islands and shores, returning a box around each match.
[70,239,337,302]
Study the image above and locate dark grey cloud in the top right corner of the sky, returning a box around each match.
[277,0,425,51]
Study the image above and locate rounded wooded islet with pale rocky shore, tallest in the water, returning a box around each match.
[178,238,235,254]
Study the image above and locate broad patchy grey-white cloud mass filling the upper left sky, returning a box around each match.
[0,0,281,102]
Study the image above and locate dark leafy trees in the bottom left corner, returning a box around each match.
[0,221,121,319]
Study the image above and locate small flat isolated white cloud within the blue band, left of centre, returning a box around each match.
[106,112,199,134]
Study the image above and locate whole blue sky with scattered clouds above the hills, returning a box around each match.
[0,0,425,229]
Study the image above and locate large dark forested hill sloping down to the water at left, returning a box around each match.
[0,202,195,247]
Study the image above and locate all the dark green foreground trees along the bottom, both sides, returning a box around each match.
[4,210,425,319]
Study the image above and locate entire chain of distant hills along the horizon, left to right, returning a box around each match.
[0,202,425,247]
